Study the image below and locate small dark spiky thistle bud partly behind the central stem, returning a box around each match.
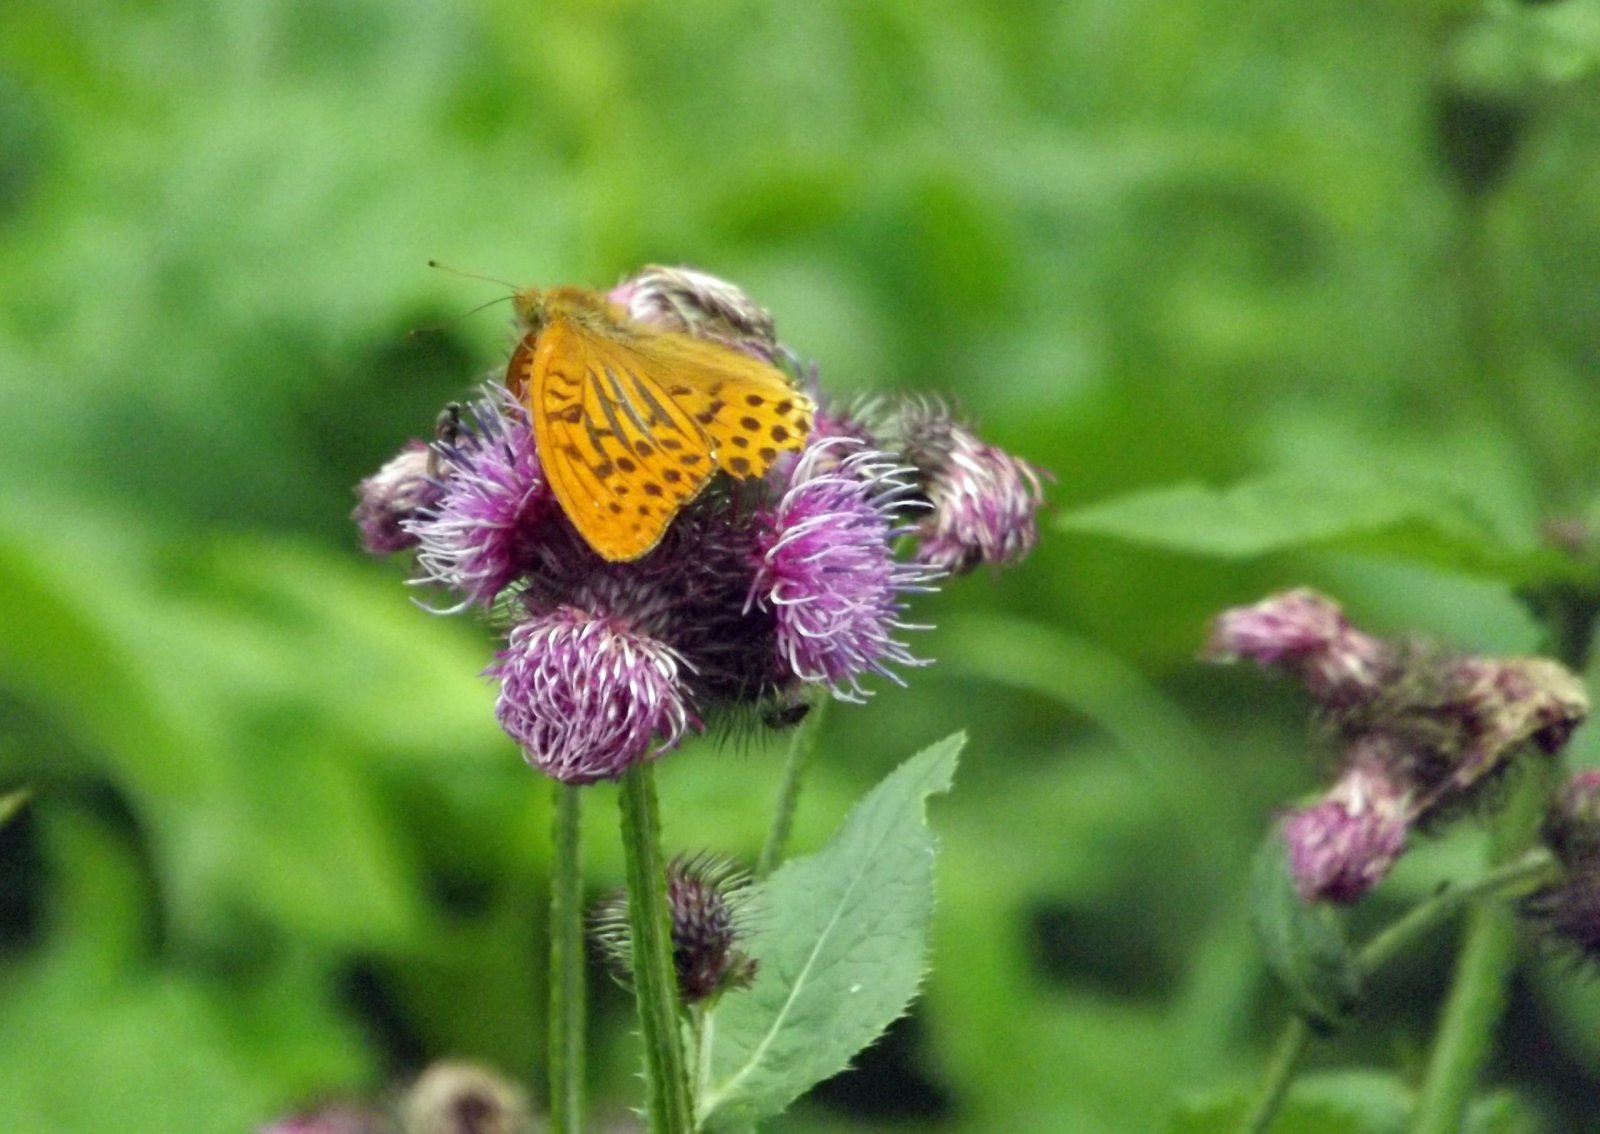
[590,854,757,1004]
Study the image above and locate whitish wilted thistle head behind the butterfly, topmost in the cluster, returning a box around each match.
[606,264,779,361]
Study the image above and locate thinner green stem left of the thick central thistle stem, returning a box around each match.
[549,784,584,1134]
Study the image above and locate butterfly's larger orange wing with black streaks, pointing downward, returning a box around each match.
[507,312,714,561]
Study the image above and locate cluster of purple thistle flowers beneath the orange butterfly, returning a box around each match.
[355,267,1042,784]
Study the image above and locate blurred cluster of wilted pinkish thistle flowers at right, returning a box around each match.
[1206,590,1600,914]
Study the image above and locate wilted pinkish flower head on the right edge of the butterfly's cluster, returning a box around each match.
[891,398,1043,574]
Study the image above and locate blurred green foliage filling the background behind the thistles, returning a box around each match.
[9,0,1600,1134]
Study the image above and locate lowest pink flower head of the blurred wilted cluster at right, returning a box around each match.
[1283,736,1410,902]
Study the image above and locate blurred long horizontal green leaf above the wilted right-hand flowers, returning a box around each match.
[1059,469,1582,584]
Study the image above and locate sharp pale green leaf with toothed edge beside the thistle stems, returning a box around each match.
[696,734,966,1131]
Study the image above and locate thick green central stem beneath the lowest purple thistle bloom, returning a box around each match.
[621,763,694,1134]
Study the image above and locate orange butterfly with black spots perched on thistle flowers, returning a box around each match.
[506,286,814,561]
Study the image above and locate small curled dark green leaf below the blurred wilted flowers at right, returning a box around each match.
[1250,830,1362,1028]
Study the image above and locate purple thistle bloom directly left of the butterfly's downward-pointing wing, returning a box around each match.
[405,387,550,608]
